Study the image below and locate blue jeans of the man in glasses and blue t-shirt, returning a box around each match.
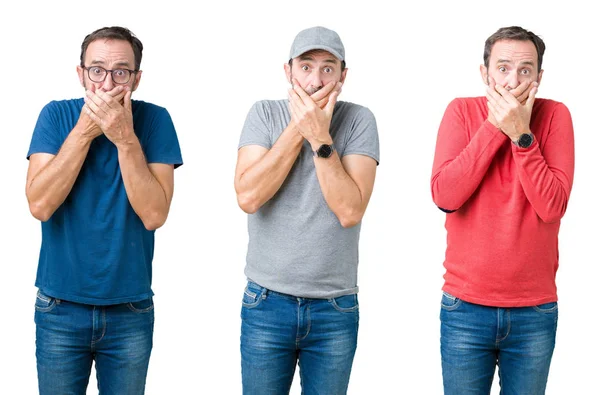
[35,292,154,395]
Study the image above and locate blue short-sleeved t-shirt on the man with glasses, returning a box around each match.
[27,99,183,305]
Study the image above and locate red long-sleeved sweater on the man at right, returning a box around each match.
[431,97,574,307]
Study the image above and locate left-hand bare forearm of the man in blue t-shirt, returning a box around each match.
[26,126,93,221]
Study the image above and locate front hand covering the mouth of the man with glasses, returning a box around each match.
[84,85,134,146]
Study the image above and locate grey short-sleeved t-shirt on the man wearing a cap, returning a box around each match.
[238,100,379,299]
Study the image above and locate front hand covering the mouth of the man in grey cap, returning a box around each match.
[288,79,339,150]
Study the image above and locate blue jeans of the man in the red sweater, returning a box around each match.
[440,293,558,395]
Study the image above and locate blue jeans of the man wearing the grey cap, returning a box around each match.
[240,282,358,395]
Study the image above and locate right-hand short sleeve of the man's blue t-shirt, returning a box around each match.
[144,107,183,168]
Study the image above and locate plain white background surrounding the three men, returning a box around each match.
[0,0,600,395]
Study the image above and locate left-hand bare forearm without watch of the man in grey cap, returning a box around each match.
[235,123,304,214]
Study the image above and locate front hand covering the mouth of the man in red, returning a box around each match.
[486,79,538,141]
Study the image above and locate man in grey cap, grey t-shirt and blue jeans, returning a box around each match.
[235,27,379,395]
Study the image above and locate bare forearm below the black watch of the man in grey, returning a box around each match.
[314,151,368,228]
